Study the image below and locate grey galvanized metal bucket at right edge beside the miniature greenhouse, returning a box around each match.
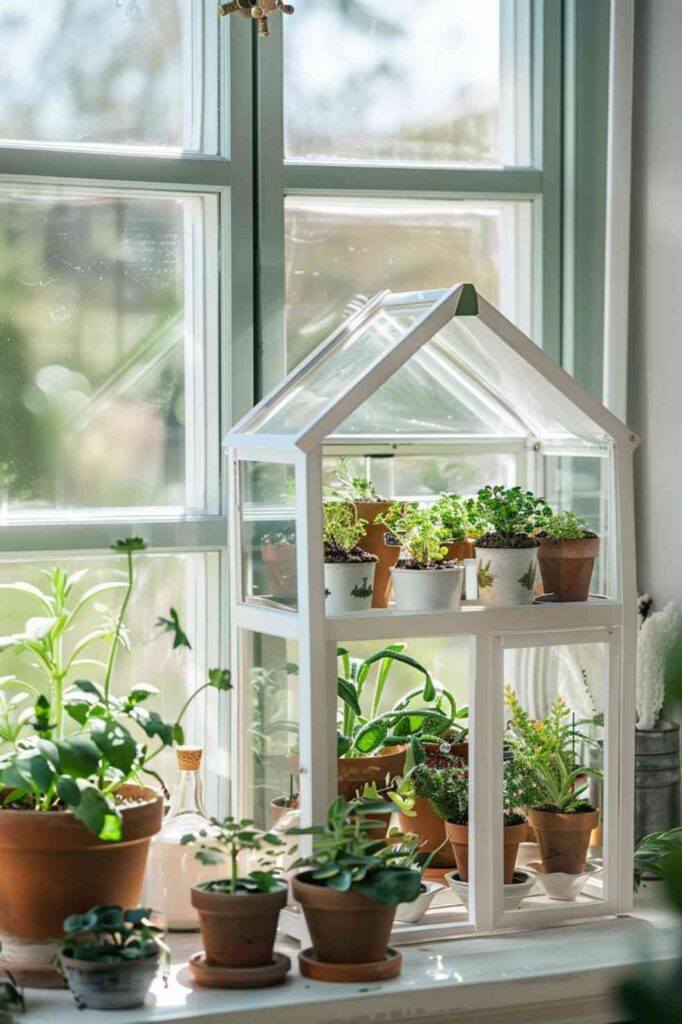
[635,722,680,843]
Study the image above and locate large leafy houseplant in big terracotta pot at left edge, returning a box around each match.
[0,538,230,954]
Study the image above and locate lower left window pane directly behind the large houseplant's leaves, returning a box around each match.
[0,553,218,787]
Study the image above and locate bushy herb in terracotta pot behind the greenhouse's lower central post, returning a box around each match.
[412,758,538,886]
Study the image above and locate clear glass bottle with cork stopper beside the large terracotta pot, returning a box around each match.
[144,746,225,932]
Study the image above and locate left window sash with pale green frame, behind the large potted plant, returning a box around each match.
[0,0,248,809]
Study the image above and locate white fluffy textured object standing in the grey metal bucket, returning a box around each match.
[637,601,680,729]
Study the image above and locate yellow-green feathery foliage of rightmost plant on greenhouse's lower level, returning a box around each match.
[505,685,602,813]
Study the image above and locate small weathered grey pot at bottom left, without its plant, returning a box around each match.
[60,953,159,1010]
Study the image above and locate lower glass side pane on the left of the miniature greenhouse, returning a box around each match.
[239,631,299,828]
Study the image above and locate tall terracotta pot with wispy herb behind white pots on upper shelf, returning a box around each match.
[330,458,399,608]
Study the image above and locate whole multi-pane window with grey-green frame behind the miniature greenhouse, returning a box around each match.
[0,0,611,813]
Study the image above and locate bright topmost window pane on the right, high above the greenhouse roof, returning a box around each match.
[285,0,529,165]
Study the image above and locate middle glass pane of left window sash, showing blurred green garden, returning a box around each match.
[0,185,217,514]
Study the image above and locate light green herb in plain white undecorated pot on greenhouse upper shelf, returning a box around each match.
[379,502,464,611]
